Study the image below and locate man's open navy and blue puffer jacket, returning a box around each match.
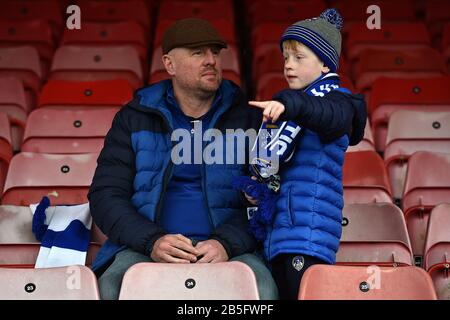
[88,80,261,273]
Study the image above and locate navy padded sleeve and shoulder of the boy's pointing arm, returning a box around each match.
[273,89,367,145]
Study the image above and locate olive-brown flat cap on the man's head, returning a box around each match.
[161,18,227,54]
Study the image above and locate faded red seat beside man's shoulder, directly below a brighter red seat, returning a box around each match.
[21,108,117,154]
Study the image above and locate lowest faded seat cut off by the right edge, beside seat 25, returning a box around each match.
[424,203,450,300]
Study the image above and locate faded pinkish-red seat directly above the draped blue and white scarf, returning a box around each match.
[2,152,98,205]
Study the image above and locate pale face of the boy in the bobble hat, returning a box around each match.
[283,41,330,89]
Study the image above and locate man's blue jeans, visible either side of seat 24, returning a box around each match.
[98,249,278,300]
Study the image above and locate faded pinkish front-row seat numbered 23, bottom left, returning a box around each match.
[0,266,100,300]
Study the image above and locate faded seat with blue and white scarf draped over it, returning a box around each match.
[0,205,105,270]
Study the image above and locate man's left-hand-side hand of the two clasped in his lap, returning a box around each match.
[150,234,201,263]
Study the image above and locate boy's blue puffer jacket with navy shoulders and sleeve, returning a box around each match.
[264,90,367,264]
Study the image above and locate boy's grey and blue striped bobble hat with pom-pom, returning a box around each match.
[280,9,344,72]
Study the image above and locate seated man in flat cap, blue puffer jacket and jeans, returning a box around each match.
[88,19,277,299]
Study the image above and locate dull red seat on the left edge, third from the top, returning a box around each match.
[0,46,42,110]
